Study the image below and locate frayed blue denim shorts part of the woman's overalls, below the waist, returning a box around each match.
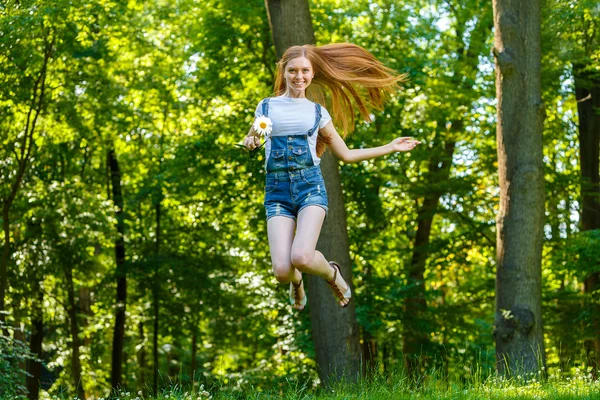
[265,165,328,220]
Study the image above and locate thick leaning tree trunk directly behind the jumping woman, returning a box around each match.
[265,0,360,386]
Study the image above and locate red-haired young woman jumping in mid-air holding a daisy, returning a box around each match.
[244,43,420,310]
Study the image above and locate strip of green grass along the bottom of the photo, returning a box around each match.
[84,374,600,400]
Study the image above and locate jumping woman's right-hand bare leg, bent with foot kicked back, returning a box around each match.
[291,206,350,306]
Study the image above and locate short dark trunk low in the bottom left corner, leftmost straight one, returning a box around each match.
[27,272,44,400]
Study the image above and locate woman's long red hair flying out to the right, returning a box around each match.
[275,43,407,157]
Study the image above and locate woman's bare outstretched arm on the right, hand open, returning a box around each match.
[321,121,421,164]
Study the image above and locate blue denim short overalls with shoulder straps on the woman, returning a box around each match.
[262,98,328,220]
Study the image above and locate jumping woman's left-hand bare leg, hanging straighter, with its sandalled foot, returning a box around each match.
[267,217,305,309]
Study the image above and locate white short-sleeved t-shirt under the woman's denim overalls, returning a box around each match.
[254,96,331,165]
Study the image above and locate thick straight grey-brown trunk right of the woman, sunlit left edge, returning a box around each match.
[493,0,545,375]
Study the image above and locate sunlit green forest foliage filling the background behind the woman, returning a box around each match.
[0,0,600,397]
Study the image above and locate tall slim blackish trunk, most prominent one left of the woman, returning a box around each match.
[108,148,127,390]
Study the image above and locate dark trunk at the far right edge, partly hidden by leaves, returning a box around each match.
[573,64,600,370]
